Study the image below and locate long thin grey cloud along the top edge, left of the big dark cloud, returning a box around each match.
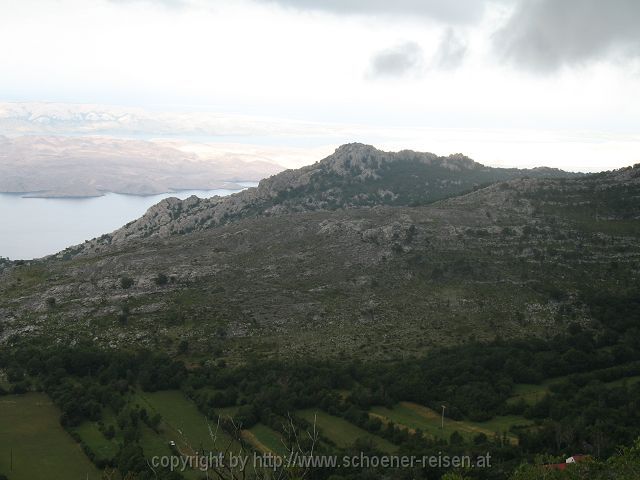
[257,0,486,23]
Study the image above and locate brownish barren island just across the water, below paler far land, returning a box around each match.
[0,136,284,198]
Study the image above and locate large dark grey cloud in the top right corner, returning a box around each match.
[494,0,640,72]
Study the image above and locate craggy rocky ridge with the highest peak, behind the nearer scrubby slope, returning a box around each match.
[76,143,578,252]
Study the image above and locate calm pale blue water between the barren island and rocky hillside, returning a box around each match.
[0,183,257,260]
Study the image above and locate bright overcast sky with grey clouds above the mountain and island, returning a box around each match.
[0,0,640,171]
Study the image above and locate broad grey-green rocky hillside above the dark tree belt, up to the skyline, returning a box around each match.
[0,145,640,361]
